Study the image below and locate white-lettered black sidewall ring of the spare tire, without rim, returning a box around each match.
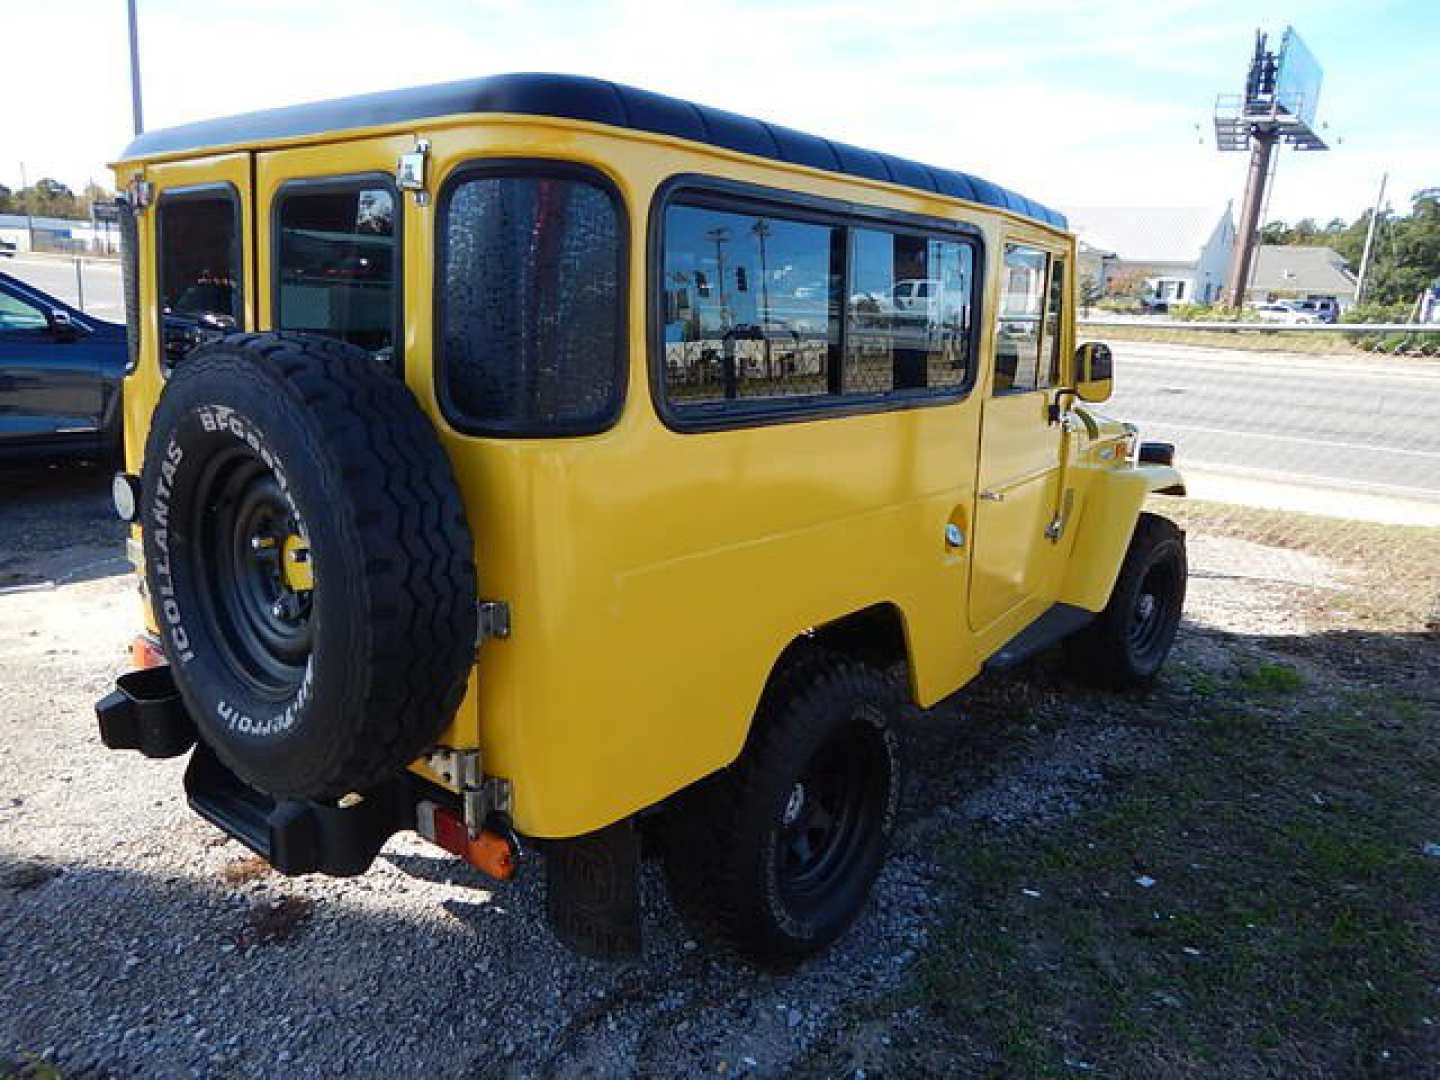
[141,360,366,795]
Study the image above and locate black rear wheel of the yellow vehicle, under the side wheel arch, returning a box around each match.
[665,652,900,966]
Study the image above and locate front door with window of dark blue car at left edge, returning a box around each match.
[0,281,101,445]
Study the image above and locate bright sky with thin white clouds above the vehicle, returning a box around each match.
[0,0,1440,223]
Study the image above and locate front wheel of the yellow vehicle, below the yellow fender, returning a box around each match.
[1066,514,1189,690]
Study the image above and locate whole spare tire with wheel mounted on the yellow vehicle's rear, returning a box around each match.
[140,333,477,799]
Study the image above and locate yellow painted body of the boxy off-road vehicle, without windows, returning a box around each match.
[115,115,1174,837]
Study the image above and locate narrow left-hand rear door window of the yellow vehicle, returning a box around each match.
[156,187,245,369]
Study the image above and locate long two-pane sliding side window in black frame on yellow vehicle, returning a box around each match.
[657,192,976,428]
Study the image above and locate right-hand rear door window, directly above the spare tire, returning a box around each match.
[275,181,400,363]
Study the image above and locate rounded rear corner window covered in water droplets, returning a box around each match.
[439,174,625,435]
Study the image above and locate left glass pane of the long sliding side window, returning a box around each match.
[662,206,844,408]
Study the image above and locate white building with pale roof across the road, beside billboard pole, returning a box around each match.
[1066,203,1236,304]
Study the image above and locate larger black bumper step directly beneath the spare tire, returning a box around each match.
[184,743,419,877]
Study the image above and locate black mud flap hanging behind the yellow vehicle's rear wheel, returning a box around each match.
[544,818,641,960]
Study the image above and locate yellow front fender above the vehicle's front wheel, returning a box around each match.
[1060,465,1185,611]
